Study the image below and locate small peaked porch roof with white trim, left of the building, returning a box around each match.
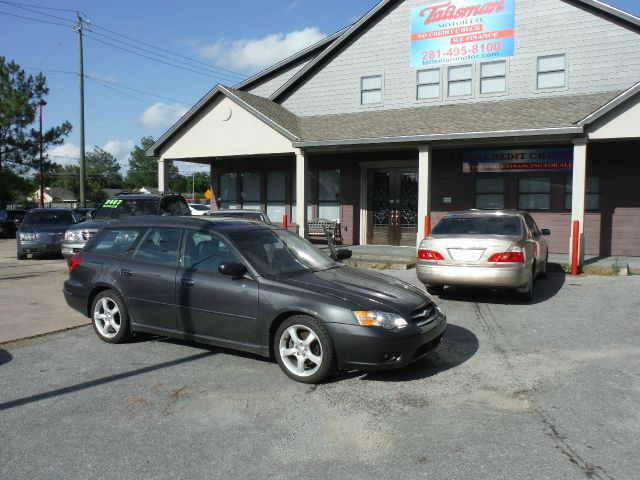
[146,85,299,157]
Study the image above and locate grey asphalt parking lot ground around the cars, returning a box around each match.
[0,239,640,479]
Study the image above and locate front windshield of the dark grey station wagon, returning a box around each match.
[229,230,339,277]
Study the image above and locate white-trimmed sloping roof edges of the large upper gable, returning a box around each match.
[269,0,640,102]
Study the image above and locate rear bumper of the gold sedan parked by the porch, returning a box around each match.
[416,261,530,288]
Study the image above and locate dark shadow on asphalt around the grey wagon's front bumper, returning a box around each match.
[330,323,480,382]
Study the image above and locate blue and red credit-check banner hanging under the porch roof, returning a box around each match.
[462,147,573,173]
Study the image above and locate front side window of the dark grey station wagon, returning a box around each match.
[182,231,241,274]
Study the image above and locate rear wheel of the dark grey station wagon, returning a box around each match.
[91,290,131,343]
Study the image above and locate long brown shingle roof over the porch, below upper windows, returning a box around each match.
[298,91,621,142]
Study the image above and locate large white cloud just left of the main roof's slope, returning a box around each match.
[198,27,325,72]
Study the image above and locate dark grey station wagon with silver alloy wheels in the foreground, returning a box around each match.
[64,216,446,383]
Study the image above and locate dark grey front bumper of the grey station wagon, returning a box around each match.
[327,314,447,370]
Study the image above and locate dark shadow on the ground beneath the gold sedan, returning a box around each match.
[439,273,566,305]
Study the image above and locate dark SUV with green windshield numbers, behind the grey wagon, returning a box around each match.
[62,193,191,261]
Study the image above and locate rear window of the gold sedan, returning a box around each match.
[431,216,522,236]
